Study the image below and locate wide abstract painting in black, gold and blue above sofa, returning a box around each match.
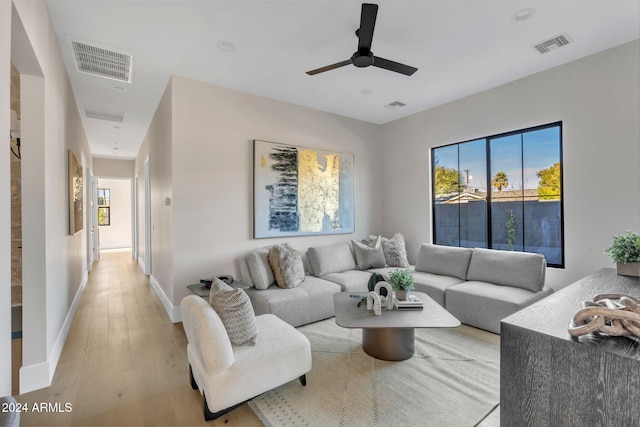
[253,140,355,239]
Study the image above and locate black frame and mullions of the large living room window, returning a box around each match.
[430,121,566,268]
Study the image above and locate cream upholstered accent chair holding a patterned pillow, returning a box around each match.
[180,295,311,421]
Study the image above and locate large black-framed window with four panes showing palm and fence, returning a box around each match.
[431,122,564,267]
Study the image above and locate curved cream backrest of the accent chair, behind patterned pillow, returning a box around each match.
[180,295,234,374]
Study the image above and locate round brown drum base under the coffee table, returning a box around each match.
[362,328,415,361]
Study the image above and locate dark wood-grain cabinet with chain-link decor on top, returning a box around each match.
[500,268,640,427]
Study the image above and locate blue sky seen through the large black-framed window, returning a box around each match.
[434,126,560,191]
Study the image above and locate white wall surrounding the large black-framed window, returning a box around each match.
[382,41,640,288]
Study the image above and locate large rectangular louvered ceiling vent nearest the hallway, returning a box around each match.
[71,40,133,83]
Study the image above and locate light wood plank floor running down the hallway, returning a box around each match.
[16,252,262,427]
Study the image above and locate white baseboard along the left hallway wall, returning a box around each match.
[20,272,89,394]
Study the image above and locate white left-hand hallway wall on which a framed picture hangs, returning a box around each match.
[7,0,91,393]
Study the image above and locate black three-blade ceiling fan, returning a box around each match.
[307,3,418,76]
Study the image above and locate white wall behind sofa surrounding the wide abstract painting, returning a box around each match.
[136,76,383,319]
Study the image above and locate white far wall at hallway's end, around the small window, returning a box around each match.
[98,178,132,249]
